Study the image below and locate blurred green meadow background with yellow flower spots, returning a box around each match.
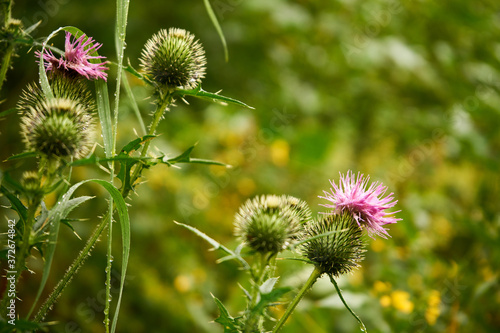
[0,0,500,333]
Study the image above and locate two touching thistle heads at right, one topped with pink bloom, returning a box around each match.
[235,171,400,277]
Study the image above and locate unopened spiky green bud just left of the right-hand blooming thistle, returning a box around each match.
[235,195,309,254]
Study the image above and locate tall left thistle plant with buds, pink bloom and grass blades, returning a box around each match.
[0,1,250,332]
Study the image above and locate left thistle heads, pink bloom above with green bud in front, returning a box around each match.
[17,33,107,159]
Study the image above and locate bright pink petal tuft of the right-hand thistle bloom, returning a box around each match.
[320,170,401,238]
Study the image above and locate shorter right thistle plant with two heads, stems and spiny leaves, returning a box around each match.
[178,171,400,333]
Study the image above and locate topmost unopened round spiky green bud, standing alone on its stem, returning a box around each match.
[140,28,206,89]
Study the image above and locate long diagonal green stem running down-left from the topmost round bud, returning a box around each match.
[34,97,172,322]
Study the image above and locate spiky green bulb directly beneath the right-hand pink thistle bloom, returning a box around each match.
[302,213,365,277]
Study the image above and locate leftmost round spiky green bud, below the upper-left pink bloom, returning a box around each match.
[21,98,94,158]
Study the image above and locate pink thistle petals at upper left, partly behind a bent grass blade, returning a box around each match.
[35,32,109,81]
